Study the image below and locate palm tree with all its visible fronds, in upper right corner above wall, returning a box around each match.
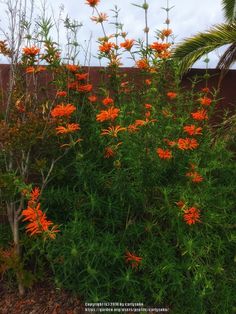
[173,0,236,78]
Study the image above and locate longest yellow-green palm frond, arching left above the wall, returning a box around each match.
[173,23,236,74]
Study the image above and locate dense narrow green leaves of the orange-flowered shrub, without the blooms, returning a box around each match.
[44,61,236,314]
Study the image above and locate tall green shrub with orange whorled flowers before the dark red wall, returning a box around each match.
[1,0,235,313]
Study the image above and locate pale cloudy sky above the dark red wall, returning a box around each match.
[0,0,229,68]
